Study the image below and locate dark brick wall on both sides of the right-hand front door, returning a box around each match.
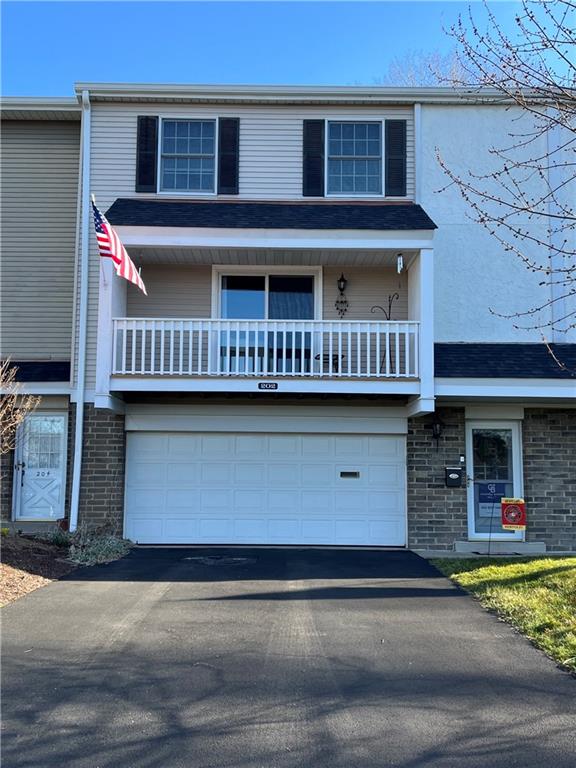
[407,408,576,552]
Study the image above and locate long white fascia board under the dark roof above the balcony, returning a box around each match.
[114,226,433,250]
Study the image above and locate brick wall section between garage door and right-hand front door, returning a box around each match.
[406,408,468,549]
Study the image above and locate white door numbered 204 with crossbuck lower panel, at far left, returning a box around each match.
[14,412,68,520]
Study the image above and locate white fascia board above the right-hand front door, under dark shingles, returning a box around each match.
[435,378,576,405]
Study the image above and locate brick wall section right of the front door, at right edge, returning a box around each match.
[522,408,576,552]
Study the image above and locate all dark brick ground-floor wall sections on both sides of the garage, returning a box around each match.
[0,403,576,552]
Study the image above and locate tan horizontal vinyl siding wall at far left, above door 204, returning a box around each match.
[0,120,80,360]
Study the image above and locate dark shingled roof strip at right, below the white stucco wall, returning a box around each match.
[434,344,576,380]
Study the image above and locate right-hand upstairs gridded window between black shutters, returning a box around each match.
[327,122,382,195]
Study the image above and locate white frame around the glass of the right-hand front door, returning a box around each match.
[466,419,530,541]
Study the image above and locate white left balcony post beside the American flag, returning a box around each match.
[94,258,127,409]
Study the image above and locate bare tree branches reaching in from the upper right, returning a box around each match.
[437,0,576,333]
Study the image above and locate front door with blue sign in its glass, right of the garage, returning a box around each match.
[466,421,523,540]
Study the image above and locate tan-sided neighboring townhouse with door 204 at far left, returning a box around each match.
[0,98,81,528]
